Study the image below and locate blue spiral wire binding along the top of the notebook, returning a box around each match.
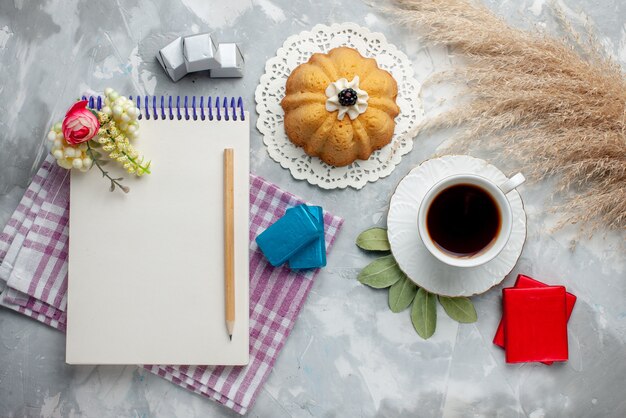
[82,96,245,121]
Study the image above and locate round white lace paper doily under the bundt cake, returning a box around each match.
[255,23,424,189]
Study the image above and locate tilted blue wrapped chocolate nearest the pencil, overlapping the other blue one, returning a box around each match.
[256,205,324,266]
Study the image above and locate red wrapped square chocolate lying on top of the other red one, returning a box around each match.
[502,286,568,363]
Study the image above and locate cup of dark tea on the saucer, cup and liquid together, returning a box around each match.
[417,173,526,267]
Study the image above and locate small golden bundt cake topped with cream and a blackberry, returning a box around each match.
[281,47,400,166]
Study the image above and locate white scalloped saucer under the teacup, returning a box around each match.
[387,155,526,296]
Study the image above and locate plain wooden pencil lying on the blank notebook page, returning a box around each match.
[224,148,235,341]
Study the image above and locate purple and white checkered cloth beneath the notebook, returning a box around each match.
[0,157,343,414]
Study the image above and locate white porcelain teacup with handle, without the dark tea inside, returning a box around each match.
[417,173,526,267]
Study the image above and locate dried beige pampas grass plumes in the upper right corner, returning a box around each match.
[386,0,626,231]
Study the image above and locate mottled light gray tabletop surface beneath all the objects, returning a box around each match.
[0,0,626,418]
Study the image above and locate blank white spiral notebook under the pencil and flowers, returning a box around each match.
[66,97,249,365]
